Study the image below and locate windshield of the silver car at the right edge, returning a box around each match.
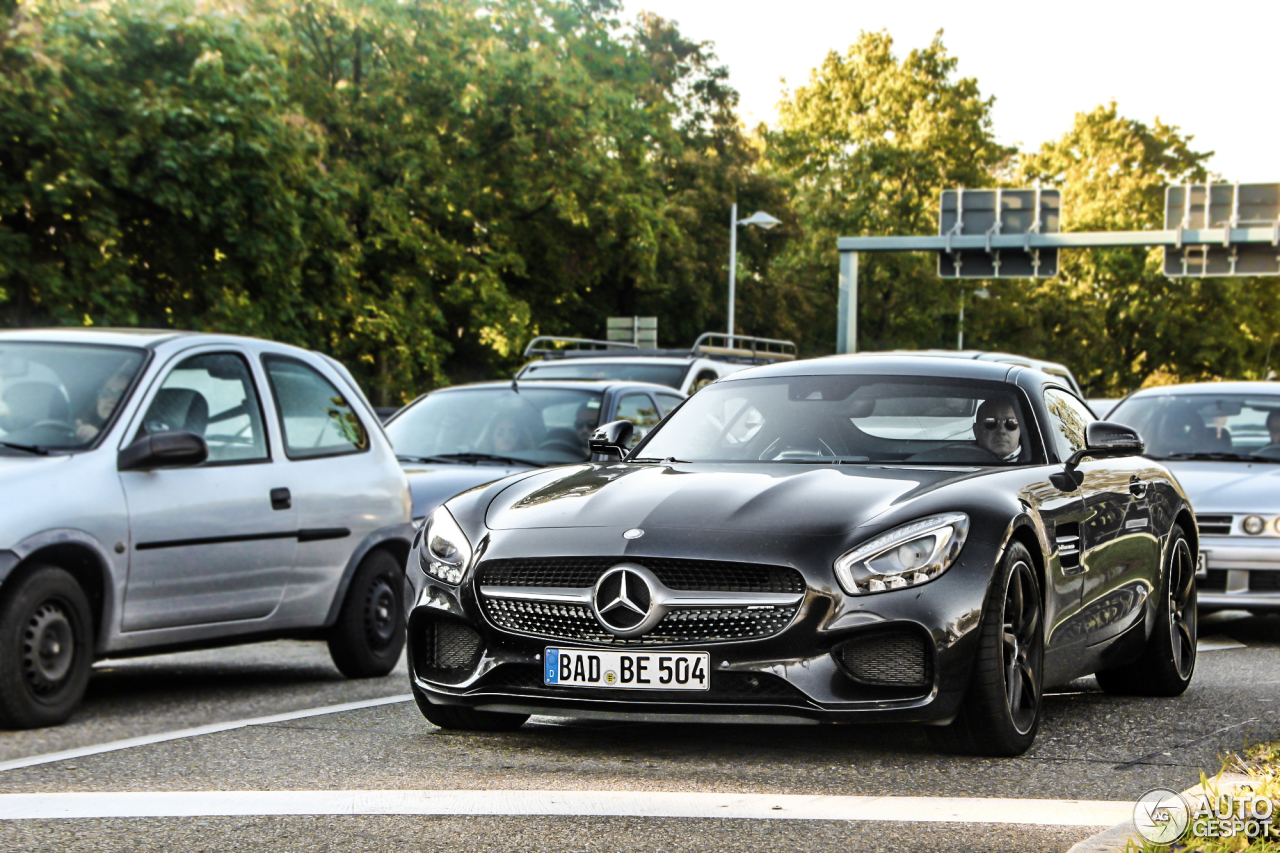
[1107,394,1280,461]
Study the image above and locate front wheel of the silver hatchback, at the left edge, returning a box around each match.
[0,566,93,729]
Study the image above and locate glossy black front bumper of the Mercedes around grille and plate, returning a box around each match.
[406,532,997,722]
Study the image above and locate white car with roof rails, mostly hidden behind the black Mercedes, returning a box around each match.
[516,332,796,394]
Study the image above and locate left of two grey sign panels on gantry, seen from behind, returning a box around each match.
[938,188,1062,278]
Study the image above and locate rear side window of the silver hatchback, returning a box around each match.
[262,356,369,459]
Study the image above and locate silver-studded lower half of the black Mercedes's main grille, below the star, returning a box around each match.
[481,597,800,646]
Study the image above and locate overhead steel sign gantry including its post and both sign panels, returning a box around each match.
[836,183,1280,352]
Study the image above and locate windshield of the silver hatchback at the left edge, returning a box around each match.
[0,342,146,452]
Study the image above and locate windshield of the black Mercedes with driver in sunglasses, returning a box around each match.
[637,375,1033,466]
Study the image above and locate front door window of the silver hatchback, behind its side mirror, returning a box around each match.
[137,352,270,464]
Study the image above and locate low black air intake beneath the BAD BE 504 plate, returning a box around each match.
[468,663,809,703]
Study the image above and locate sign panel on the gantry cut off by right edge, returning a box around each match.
[1165,183,1280,278]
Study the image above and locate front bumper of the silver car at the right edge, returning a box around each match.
[1197,535,1280,612]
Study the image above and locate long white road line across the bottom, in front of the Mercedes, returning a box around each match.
[0,790,1133,826]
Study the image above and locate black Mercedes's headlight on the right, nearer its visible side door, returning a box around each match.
[836,512,969,596]
